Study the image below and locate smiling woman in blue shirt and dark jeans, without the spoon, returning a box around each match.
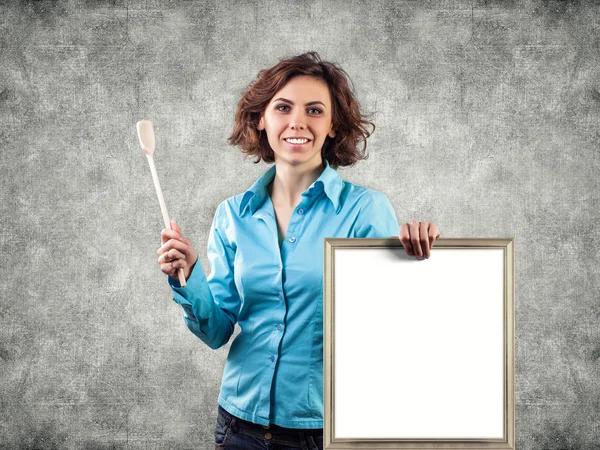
[157,52,440,449]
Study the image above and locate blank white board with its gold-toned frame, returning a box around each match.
[323,238,515,450]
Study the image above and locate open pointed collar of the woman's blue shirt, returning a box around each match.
[240,160,343,216]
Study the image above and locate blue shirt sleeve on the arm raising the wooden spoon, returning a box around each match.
[168,204,240,349]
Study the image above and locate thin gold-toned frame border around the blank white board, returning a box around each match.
[323,238,515,450]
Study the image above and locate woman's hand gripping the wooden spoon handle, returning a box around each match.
[156,220,198,280]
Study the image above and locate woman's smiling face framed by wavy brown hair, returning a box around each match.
[258,75,335,169]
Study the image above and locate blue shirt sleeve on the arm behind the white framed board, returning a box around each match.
[354,191,400,238]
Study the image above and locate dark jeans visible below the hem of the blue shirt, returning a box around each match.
[215,405,323,450]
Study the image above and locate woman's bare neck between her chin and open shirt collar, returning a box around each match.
[269,160,325,208]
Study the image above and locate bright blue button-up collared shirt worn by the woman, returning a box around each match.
[168,162,400,428]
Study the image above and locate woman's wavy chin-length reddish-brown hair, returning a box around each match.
[229,52,375,169]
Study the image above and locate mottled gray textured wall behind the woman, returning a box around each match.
[0,0,600,449]
